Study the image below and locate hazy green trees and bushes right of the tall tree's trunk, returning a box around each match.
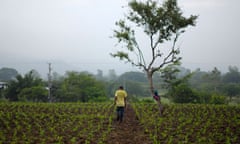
[162,66,240,104]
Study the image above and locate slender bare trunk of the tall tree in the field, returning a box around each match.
[147,71,163,116]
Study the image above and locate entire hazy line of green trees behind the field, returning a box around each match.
[0,66,240,104]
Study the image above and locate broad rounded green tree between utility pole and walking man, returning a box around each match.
[57,72,106,102]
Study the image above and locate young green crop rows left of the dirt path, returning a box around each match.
[0,103,113,144]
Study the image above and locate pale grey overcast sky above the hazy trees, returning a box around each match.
[0,0,240,76]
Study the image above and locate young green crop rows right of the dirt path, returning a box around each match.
[133,103,240,144]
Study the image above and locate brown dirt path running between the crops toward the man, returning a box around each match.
[106,105,152,144]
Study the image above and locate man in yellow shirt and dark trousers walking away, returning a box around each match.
[114,86,127,122]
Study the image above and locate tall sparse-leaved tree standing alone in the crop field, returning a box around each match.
[111,0,197,112]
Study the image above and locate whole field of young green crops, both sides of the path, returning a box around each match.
[0,103,240,144]
